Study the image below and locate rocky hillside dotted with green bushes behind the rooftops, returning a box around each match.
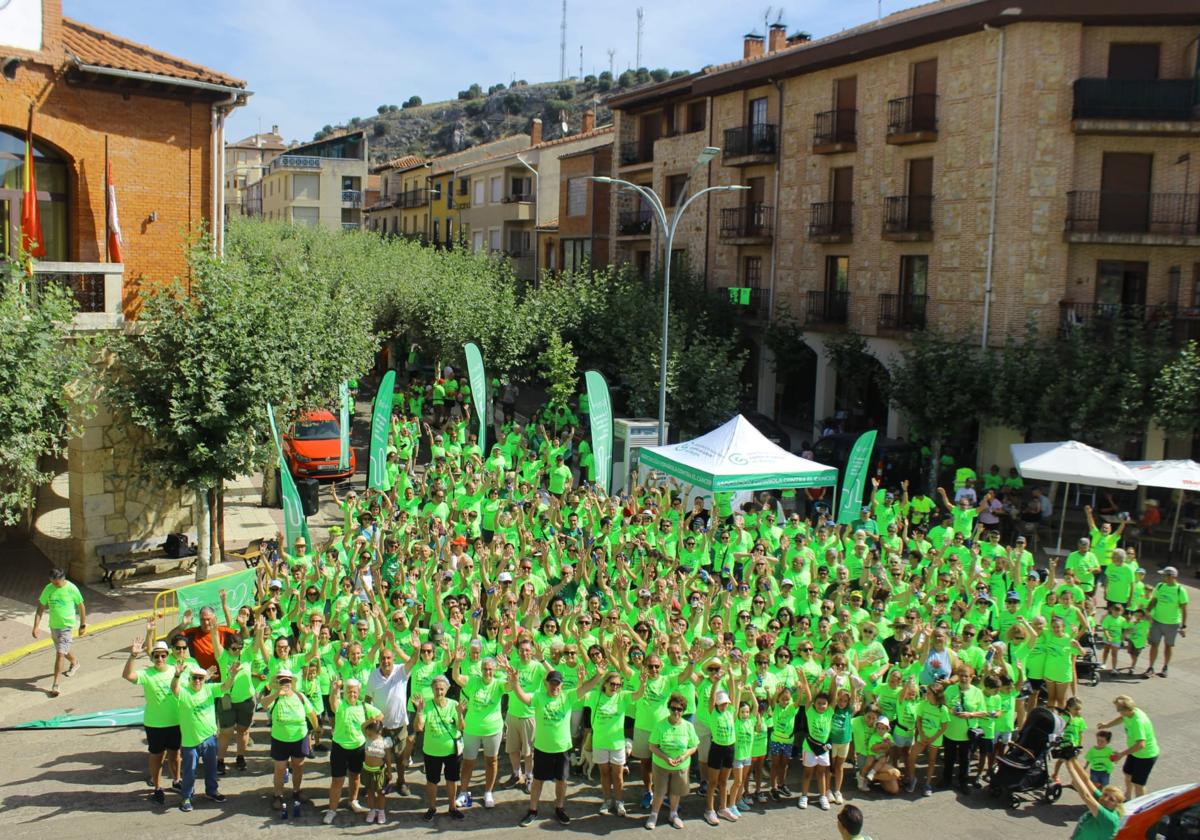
[313,68,688,163]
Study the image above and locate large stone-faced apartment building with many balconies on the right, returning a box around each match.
[610,0,1200,448]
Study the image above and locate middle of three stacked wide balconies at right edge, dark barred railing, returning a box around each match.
[1063,190,1200,245]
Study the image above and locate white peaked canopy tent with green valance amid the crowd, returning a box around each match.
[638,414,838,492]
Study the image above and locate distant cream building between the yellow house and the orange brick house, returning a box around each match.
[455,112,613,280]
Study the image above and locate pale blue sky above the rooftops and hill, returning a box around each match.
[62,0,892,139]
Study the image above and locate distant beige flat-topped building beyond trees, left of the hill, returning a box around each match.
[257,131,367,230]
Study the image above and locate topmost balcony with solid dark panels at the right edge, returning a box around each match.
[1072,79,1200,136]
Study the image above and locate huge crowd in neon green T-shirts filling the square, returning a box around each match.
[91,386,1188,836]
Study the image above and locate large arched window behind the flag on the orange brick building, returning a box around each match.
[0,128,71,262]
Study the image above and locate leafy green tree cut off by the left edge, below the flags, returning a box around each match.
[0,259,95,524]
